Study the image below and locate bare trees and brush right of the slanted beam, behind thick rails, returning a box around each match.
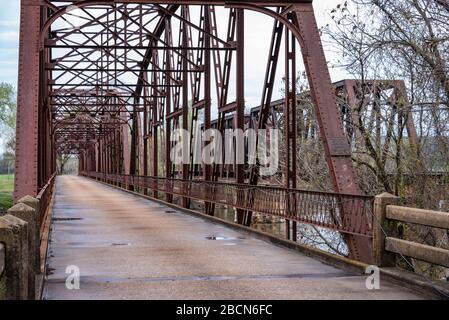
[323,0,449,278]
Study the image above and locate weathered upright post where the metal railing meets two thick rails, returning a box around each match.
[373,193,399,267]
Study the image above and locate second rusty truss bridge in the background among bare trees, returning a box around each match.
[250,79,419,145]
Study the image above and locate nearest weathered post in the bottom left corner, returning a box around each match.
[0,214,29,300]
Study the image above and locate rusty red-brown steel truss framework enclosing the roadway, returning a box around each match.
[15,0,378,262]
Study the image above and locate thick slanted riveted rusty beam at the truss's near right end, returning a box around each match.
[290,4,372,263]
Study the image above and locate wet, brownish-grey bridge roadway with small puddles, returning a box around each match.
[44,176,420,299]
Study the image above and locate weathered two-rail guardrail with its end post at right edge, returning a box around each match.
[374,194,449,268]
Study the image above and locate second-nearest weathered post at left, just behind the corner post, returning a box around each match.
[8,202,40,300]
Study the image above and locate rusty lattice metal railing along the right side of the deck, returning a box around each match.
[80,172,374,237]
